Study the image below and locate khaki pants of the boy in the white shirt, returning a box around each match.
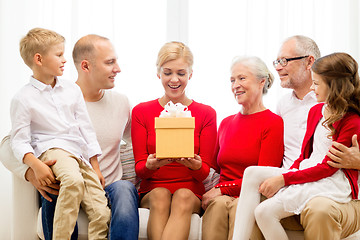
[40,148,110,240]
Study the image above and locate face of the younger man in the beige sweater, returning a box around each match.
[91,40,121,89]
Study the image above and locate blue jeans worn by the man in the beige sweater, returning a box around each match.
[41,180,139,240]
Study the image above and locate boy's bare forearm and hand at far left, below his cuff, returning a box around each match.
[23,153,56,186]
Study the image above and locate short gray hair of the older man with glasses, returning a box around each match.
[284,35,321,60]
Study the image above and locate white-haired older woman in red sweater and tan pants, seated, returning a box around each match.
[202,57,284,240]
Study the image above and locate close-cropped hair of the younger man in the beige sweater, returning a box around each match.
[72,34,109,65]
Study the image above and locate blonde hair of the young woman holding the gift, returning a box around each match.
[156,42,194,73]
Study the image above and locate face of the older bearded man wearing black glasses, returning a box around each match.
[276,39,307,89]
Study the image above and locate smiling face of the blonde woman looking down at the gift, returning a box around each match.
[158,58,192,102]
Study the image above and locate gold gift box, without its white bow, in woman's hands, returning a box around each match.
[155,117,195,158]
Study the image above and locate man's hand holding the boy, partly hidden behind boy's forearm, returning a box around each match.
[25,160,60,202]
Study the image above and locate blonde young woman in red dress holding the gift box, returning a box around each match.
[131,42,216,239]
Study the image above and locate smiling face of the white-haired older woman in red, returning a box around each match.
[230,63,265,107]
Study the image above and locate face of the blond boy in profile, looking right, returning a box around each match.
[42,43,66,77]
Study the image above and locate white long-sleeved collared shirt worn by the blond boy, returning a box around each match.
[10,77,101,163]
